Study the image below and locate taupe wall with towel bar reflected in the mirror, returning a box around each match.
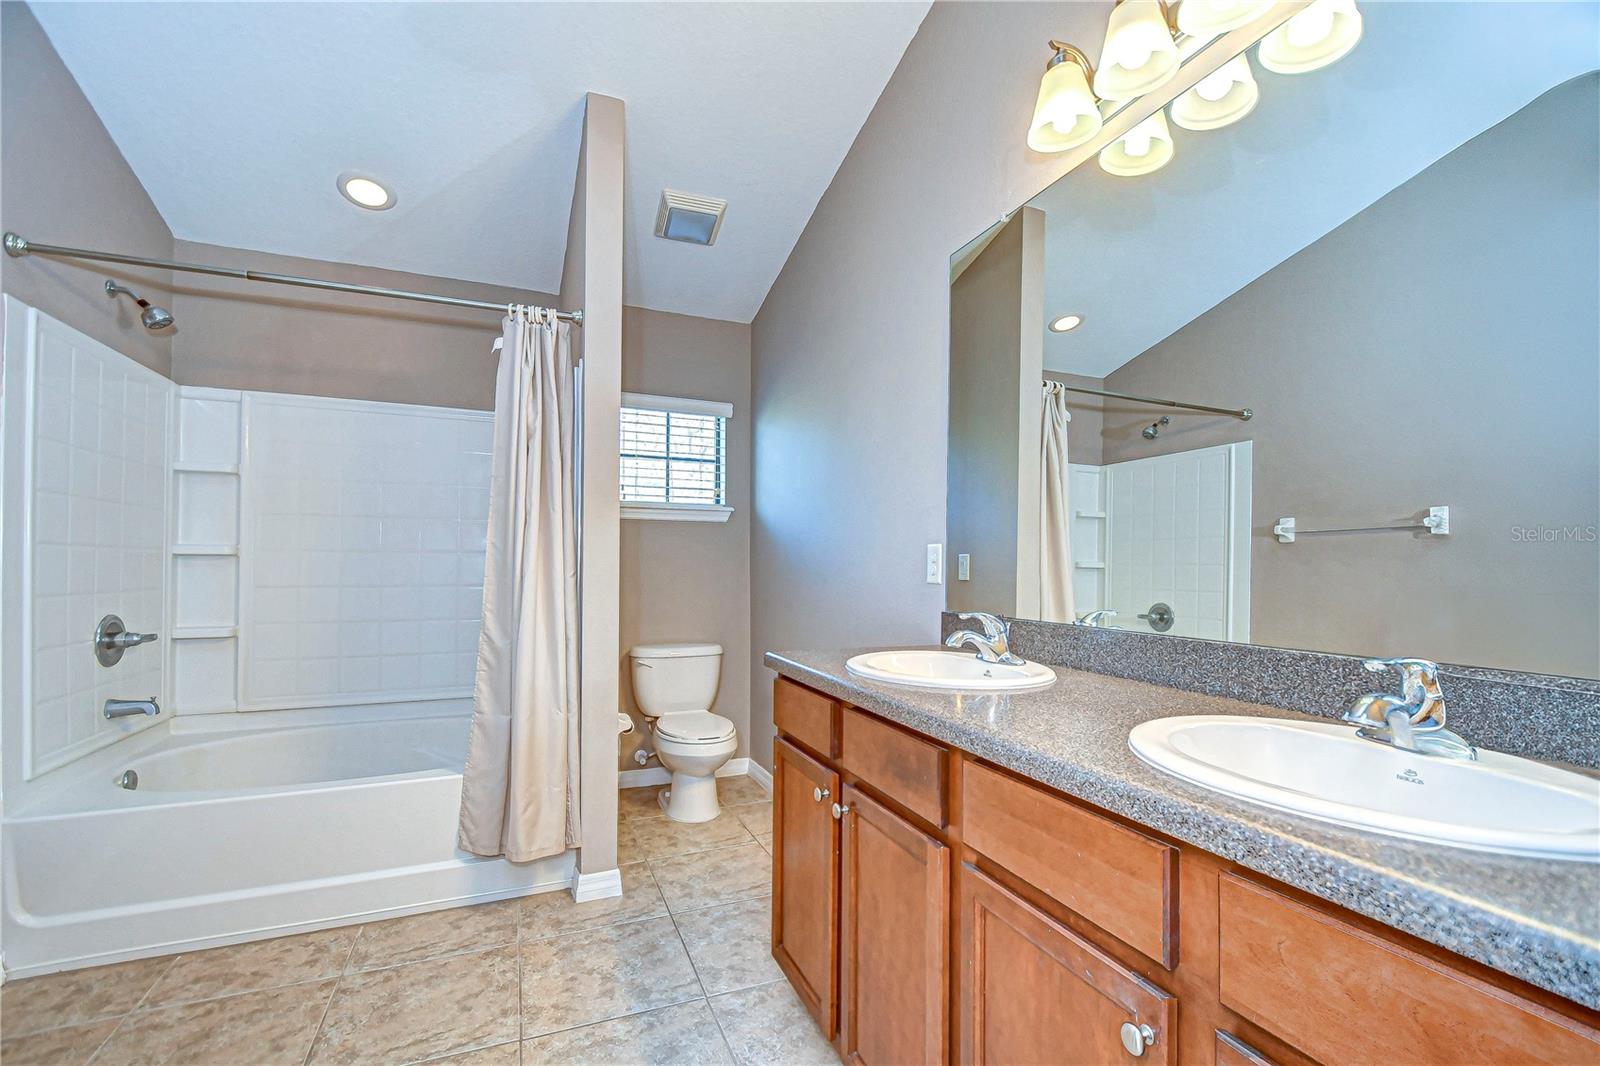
[1104,75,1600,677]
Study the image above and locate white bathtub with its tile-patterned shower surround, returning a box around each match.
[0,298,574,976]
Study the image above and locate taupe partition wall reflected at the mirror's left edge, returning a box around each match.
[944,208,1045,618]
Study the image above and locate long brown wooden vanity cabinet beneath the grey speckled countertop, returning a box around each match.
[773,679,1600,1066]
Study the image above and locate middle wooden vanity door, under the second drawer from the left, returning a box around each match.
[840,786,950,1066]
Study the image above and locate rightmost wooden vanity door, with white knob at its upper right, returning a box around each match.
[960,866,1178,1066]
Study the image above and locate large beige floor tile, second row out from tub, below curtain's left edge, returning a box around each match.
[310,948,518,1063]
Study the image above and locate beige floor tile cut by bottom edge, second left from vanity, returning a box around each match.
[522,1000,733,1066]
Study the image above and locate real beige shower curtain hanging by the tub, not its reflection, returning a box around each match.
[458,307,578,863]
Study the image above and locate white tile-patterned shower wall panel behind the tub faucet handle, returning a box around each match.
[23,302,173,776]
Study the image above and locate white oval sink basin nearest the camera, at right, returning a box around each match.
[1128,715,1600,863]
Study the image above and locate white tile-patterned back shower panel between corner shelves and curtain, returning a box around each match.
[240,394,493,709]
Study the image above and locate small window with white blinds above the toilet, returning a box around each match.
[619,392,733,522]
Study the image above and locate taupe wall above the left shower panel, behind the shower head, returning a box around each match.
[0,3,173,375]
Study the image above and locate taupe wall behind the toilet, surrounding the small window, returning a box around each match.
[621,307,750,770]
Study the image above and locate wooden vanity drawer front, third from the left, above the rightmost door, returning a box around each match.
[962,762,1178,968]
